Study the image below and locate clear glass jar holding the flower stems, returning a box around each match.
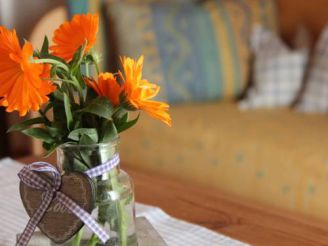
[54,141,138,246]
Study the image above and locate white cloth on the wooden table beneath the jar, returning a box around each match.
[0,158,245,246]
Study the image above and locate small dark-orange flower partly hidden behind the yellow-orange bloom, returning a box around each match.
[85,73,123,107]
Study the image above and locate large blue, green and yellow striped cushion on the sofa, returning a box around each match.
[108,0,276,103]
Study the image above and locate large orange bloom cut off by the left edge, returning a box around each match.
[0,26,56,116]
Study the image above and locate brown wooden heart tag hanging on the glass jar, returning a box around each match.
[20,172,95,244]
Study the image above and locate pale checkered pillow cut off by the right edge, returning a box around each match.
[296,26,328,113]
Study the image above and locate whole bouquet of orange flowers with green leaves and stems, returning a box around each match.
[0,14,171,245]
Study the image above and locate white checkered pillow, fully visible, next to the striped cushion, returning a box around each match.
[239,26,308,109]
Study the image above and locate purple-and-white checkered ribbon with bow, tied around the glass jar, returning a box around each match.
[16,154,120,246]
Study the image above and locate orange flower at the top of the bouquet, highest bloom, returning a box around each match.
[50,14,99,61]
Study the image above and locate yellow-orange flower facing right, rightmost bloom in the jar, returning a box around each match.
[119,56,172,126]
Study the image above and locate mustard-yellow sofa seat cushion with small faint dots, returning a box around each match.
[120,103,328,219]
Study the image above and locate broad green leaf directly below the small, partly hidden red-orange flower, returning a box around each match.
[79,97,113,120]
